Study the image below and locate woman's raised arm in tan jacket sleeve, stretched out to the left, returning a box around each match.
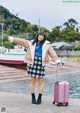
[8,36,29,48]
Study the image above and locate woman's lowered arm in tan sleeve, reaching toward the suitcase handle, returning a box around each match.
[48,46,61,64]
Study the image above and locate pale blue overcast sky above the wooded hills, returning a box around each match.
[0,0,80,30]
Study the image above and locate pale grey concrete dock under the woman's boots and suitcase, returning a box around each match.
[0,92,80,113]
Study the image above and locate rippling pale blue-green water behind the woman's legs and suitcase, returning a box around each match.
[0,72,80,98]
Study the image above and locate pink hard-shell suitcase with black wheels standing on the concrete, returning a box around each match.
[53,81,69,106]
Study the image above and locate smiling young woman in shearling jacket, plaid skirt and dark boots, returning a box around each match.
[9,32,60,104]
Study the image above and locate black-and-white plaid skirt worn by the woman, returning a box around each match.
[27,57,45,77]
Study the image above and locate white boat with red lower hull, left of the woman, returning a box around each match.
[0,46,27,69]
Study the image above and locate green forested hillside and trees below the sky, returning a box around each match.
[0,6,80,48]
